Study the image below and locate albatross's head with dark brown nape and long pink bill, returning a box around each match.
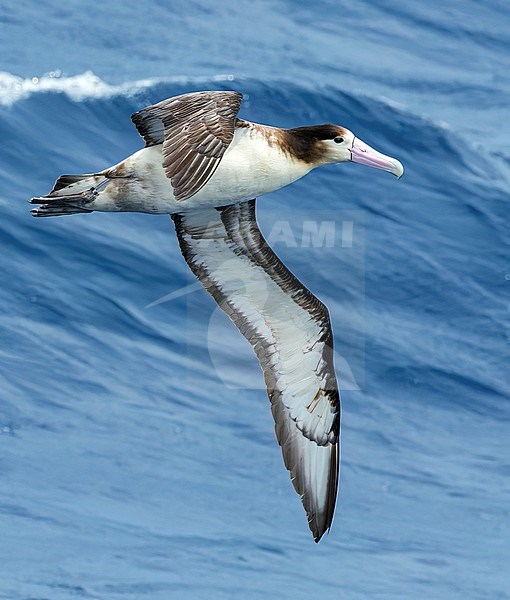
[288,123,404,179]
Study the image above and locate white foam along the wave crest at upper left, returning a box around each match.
[0,71,234,106]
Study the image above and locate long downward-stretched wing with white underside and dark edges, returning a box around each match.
[172,200,340,542]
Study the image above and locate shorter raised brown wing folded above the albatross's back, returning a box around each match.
[131,92,243,200]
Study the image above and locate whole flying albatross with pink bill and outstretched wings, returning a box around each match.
[30,91,404,542]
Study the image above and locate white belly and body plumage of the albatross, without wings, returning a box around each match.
[91,127,311,213]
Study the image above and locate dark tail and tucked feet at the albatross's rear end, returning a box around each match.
[29,174,108,217]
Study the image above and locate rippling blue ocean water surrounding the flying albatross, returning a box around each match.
[0,0,510,600]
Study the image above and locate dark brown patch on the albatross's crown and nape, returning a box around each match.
[278,123,346,164]
